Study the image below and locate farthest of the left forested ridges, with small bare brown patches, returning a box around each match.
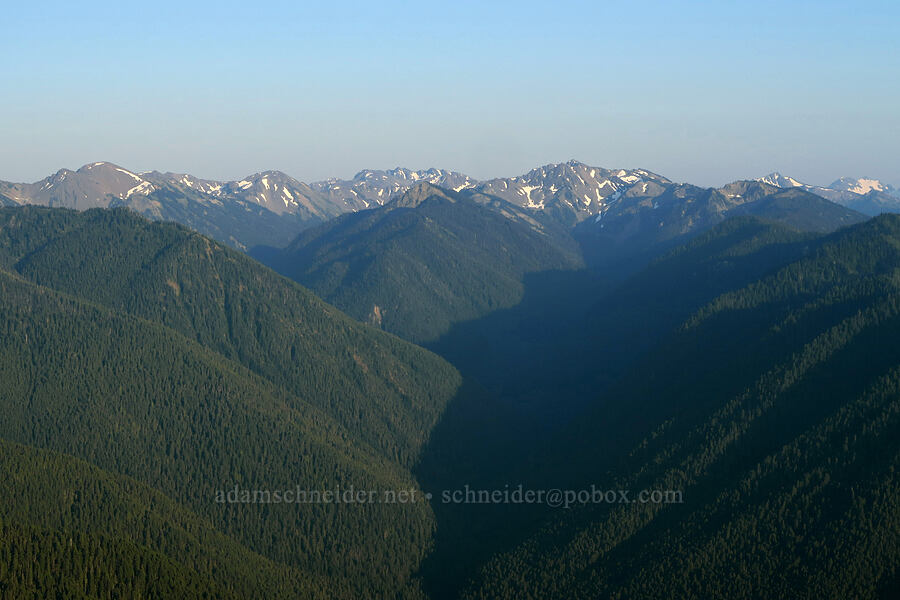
[0,208,458,465]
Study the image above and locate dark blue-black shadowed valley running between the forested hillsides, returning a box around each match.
[418,217,818,598]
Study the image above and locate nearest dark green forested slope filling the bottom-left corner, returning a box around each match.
[0,440,330,600]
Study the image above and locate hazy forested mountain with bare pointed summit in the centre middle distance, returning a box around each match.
[260,187,580,342]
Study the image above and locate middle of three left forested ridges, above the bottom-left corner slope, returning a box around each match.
[0,273,446,596]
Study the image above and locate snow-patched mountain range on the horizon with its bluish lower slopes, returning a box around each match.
[0,161,900,250]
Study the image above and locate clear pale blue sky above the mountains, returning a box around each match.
[0,0,900,185]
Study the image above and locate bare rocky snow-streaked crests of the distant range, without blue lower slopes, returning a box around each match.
[0,160,900,220]
